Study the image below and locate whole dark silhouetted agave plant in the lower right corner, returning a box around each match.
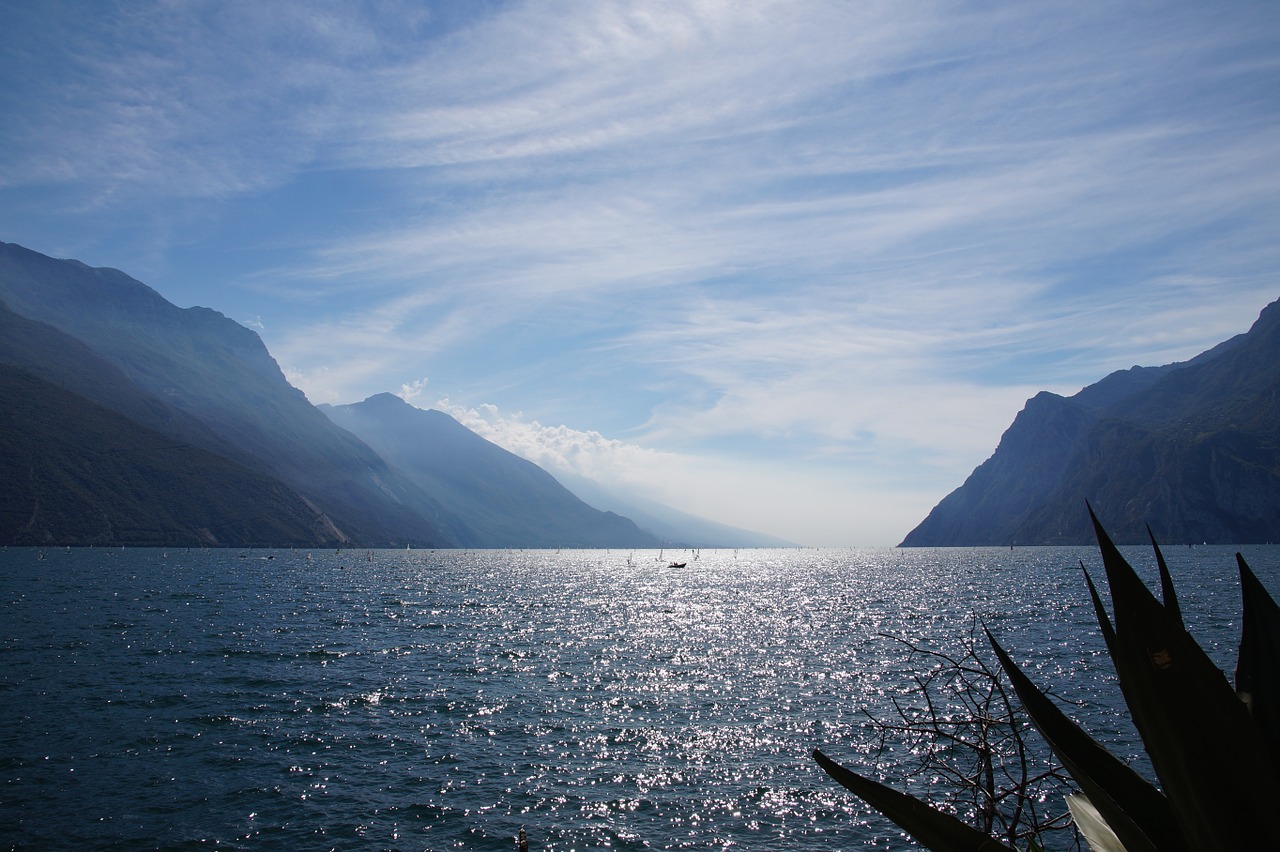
[813,508,1280,852]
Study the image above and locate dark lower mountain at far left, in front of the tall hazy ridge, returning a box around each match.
[0,303,344,546]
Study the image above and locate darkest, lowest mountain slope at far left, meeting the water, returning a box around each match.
[0,363,342,546]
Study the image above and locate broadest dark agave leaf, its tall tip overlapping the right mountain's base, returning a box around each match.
[1089,508,1280,851]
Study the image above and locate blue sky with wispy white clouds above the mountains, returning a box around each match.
[0,0,1280,546]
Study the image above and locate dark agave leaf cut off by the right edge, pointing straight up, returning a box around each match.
[1235,554,1280,771]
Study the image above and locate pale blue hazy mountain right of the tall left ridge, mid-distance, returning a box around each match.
[320,394,659,548]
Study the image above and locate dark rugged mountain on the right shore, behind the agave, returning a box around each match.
[902,295,1280,546]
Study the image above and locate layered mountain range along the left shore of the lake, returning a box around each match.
[0,243,749,548]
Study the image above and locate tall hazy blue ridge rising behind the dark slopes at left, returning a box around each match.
[0,243,457,546]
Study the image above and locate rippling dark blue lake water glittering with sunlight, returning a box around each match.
[0,546,1280,851]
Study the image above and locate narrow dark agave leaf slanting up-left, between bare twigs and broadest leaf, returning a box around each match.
[987,631,1188,852]
